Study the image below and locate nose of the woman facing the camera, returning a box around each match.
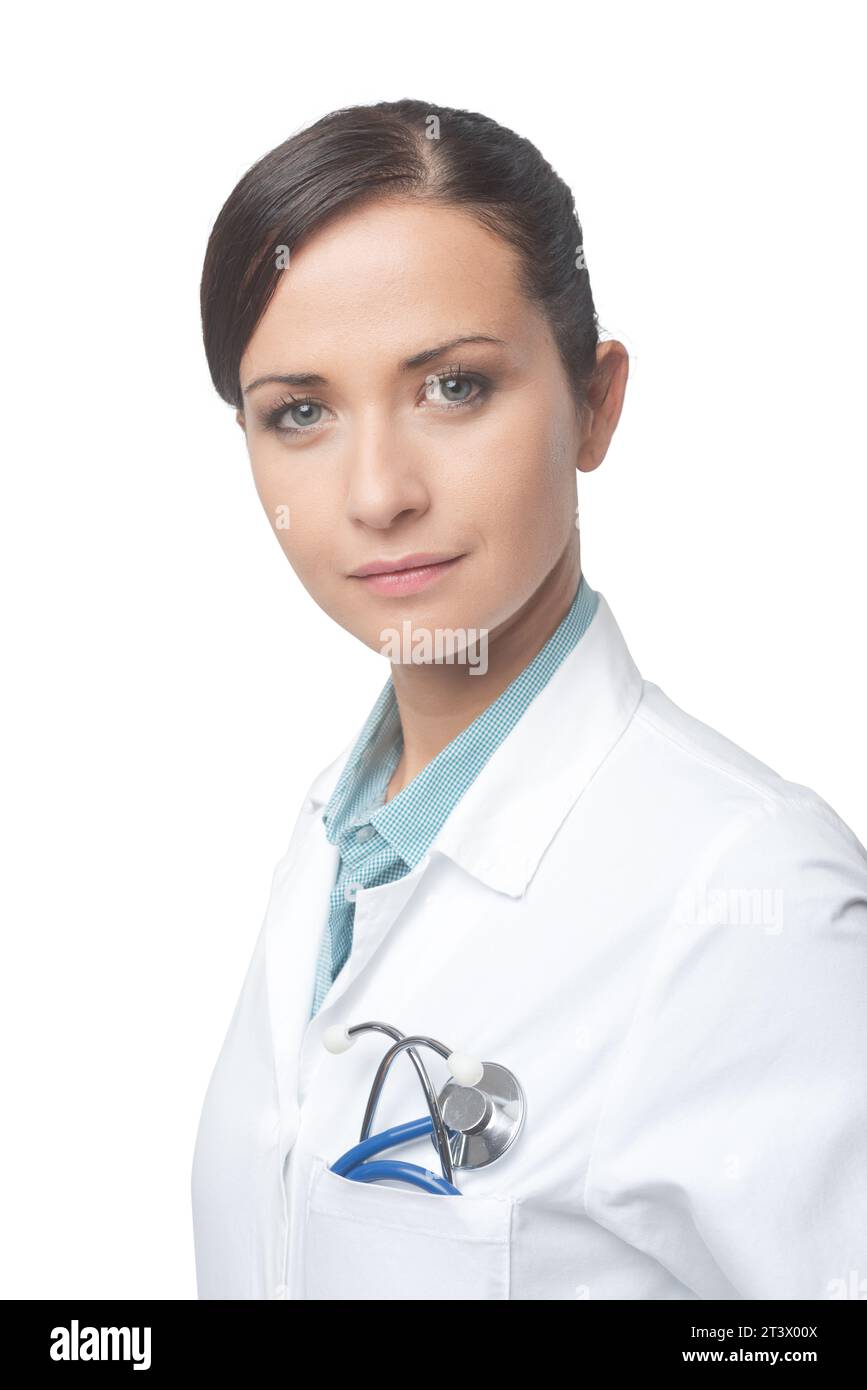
[346,410,431,531]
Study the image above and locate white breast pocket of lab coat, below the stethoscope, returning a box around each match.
[304,1155,514,1301]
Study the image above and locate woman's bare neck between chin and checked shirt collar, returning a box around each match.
[386,542,581,801]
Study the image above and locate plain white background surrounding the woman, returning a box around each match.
[0,0,867,1298]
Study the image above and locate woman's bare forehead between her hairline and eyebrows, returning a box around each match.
[242,200,543,375]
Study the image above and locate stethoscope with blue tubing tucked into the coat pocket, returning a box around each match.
[322,1023,527,1197]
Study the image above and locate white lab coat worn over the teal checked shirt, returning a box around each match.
[192,595,867,1300]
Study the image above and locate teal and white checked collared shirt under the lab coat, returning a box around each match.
[310,575,599,1017]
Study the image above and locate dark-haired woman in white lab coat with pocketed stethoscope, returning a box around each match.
[192,100,867,1300]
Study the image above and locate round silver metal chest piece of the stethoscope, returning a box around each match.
[431,1062,524,1168]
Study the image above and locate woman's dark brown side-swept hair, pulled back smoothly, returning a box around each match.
[200,99,599,410]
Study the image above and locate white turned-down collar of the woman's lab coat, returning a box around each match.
[304,592,643,897]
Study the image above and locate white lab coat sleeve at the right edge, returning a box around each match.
[585,788,867,1300]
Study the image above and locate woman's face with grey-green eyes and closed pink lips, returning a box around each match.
[238,202,616,651]
